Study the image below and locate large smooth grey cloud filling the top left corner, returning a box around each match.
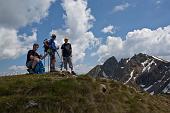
[0,0,55,28]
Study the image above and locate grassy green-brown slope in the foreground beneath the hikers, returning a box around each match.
[0,75,170,113]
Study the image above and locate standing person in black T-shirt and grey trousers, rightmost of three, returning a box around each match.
[61,37,76,75]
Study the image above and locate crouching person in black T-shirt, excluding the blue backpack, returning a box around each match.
[26,43,41,73]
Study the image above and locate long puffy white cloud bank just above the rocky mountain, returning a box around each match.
[95,26,170,61]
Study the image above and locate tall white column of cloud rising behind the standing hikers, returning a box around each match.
[52,0,99,62]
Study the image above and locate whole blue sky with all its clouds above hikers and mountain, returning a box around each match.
[0,0,170,75]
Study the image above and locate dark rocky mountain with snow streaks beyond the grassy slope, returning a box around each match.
[88,53,170,94]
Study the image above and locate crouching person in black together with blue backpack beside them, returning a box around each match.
[26,43,44,74]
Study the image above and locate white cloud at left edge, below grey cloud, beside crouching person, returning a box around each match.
[0,28,37,60]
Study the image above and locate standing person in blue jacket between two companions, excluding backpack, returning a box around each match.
[48,34,59,72]
